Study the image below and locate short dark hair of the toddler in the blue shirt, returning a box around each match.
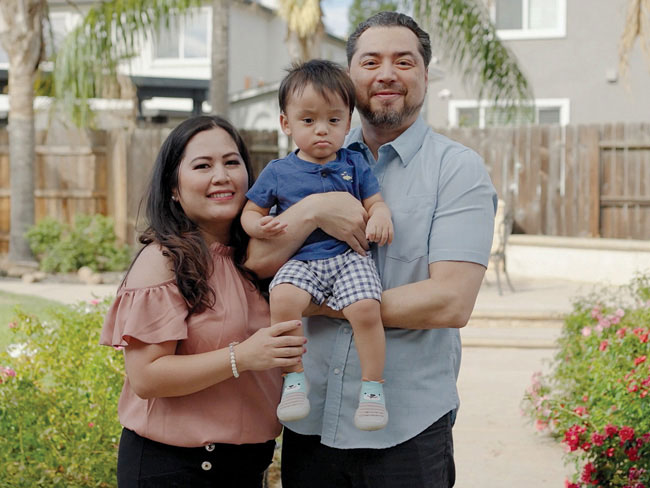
[278,59,355,114]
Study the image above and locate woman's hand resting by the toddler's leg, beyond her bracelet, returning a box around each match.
[235,320,307,372]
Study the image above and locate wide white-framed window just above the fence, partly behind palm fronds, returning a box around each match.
[449,98,569,128]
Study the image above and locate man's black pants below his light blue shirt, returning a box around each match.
[282,413,456,488]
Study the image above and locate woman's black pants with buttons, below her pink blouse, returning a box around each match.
[117,429,275,488]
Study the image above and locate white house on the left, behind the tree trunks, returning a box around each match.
[0,0,346,150]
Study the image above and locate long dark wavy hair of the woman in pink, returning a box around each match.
[140,115,260,314]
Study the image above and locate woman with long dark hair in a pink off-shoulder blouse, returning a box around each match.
[101,116,305,488]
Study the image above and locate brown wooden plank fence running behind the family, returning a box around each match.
[0,124,650,252]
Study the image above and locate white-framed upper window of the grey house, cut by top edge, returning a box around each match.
[492,0,566,40]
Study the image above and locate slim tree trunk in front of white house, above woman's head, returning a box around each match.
[210,0,230,117]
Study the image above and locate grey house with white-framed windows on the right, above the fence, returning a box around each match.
[427,0,650,127]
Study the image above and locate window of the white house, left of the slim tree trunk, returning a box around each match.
[154,9,210,60]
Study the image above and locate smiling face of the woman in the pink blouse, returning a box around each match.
[173,127,248,244]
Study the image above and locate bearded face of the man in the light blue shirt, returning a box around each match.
[350,26,428,130]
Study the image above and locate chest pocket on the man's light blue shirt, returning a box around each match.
[386,195,436,262]
